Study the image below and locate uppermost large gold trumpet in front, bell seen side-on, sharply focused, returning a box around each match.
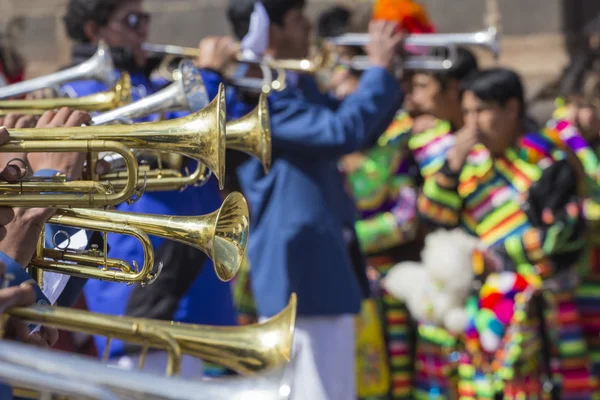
[0,85,226,207]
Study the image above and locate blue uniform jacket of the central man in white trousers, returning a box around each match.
[238,68,402,317]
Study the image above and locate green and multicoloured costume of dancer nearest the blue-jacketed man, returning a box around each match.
[342,112,454,399]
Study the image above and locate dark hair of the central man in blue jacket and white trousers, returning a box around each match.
[227,0,306,40]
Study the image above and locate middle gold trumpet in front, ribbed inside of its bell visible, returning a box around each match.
[30,192,250,284]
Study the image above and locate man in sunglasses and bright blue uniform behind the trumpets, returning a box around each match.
[58,0,236,377]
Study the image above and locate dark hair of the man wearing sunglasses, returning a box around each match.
[63,0,123,43]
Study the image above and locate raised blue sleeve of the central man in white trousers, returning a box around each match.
[269,68,402,158]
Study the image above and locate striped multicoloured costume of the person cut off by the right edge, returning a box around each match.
[544,117,600,396]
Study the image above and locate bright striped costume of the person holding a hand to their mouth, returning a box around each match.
[418,133,592,399]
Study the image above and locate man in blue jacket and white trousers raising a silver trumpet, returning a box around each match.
[206,0,402,400]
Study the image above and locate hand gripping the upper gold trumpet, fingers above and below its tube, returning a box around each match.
[27,108,92,180]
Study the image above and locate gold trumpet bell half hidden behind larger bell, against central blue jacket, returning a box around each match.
[226,93,271,173]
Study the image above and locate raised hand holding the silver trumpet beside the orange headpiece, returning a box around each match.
[366,21,404,70]
